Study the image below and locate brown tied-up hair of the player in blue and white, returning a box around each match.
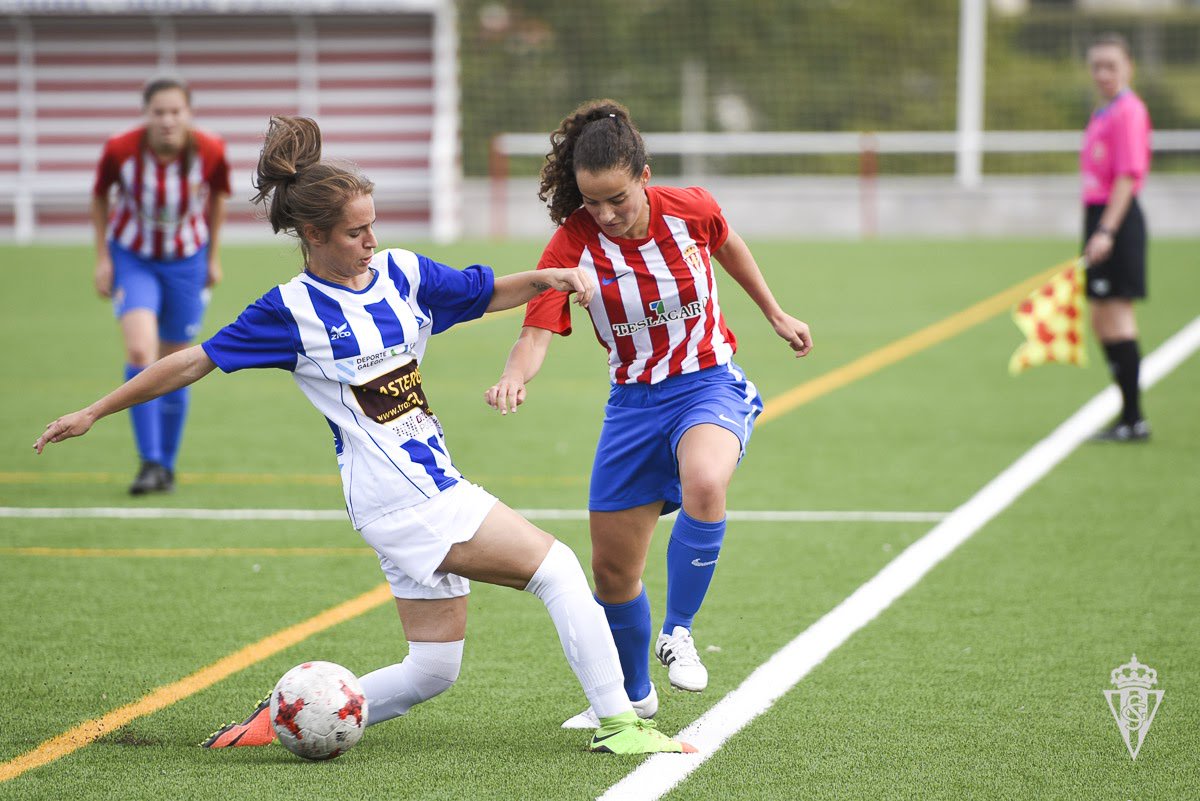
[251,116,374,263]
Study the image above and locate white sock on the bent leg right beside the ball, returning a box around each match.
[359,640,463,725]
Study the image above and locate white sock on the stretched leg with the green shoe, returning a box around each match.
[526,540,634,717]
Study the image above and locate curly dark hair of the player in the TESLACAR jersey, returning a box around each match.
[538,100,649,225]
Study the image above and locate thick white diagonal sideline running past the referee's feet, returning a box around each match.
[600,318,1200,801]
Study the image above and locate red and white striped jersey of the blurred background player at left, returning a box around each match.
[92,127,229,261]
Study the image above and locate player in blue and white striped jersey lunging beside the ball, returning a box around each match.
[35,118,695,753]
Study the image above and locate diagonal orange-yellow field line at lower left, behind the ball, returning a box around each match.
[0,584,391,782]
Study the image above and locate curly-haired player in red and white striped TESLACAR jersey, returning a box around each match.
[486,100,812,728]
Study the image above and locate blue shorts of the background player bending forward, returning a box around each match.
[108,242,210,342]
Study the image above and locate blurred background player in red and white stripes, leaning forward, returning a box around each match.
[91,76,229,495]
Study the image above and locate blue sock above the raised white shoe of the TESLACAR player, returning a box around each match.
[662,510,725,634]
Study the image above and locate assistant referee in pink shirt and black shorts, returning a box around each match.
[1079,34,1150,442]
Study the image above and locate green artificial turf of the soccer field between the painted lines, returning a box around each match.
[0,240,1200,800]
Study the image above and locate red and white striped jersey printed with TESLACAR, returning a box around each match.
[524,186,737,384]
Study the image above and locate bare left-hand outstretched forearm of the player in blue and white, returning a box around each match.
[34,345,216,453]
